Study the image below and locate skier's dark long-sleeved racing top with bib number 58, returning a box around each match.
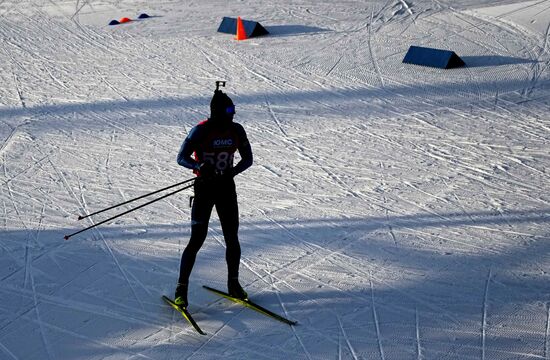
[178,119,253,175]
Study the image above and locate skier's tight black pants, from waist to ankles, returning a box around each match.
[178,177,241,284]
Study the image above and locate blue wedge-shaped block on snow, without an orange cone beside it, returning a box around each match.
[403,46,466,69]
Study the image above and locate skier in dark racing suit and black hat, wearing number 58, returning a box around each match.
[174,81,252,308]
